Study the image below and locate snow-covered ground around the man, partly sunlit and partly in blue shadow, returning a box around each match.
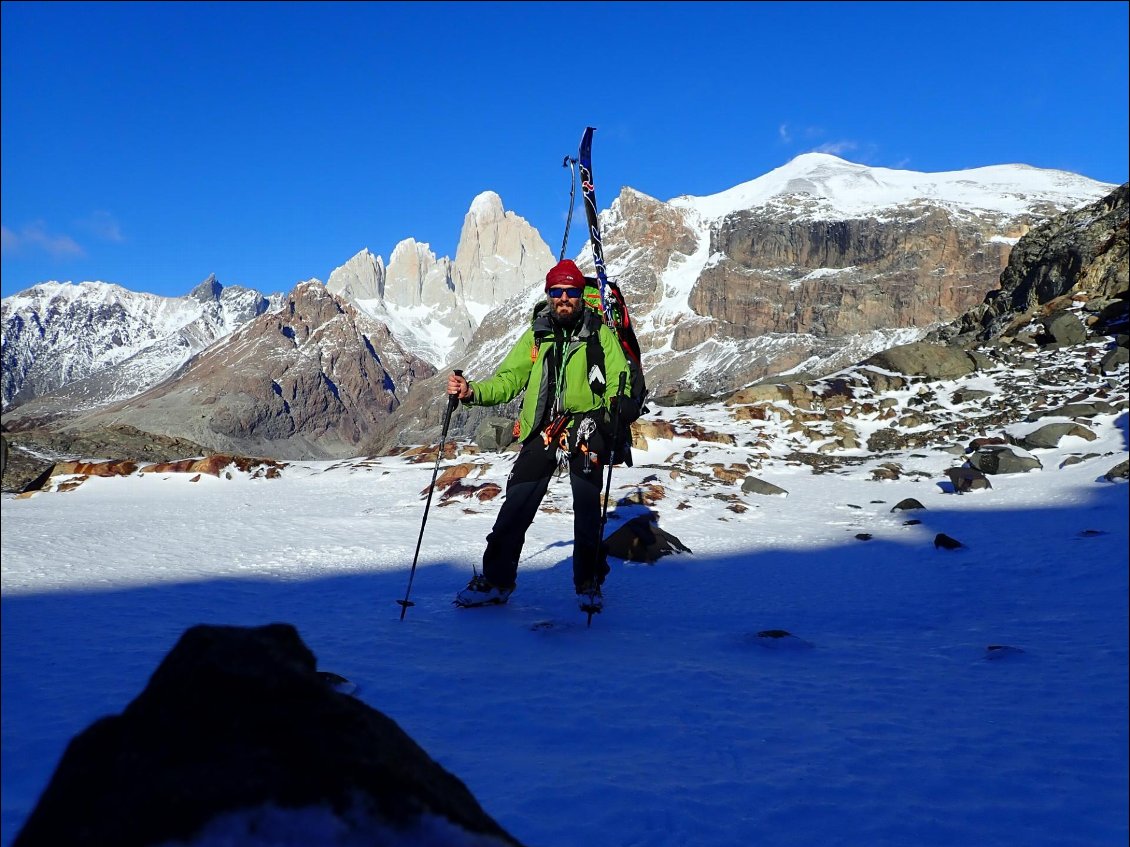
[0,334,1130,847]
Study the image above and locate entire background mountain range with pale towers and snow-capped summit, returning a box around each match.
[2,154,1125,467]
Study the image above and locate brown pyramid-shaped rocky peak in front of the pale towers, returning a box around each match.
[64,280,435,459]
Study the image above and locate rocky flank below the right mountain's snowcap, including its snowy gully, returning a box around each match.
[596,189,1037,394]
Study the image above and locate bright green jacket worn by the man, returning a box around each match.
[466,308,632,442]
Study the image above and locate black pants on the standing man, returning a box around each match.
[483,433,609,588]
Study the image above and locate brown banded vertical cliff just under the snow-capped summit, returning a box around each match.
[690,207,1009,338]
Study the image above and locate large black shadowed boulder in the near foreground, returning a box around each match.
[15,623,519,847]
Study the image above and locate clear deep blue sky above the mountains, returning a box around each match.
[0,2,1130,296]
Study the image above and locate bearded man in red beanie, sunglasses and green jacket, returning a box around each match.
[447,259,631,611]
